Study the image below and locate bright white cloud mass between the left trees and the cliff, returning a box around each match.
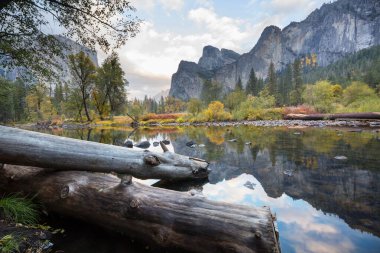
[119,8,261,97]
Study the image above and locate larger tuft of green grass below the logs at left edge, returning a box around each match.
[0,195,38,225]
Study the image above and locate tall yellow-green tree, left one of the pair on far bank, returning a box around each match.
[69,52,96,121]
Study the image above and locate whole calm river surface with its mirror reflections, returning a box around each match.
[36,126,380,253]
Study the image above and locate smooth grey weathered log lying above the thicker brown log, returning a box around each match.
[0,126,209,179]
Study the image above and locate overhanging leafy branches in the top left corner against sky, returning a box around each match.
[0,0,141,79]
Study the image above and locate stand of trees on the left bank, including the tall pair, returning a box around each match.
[0,52,128,122]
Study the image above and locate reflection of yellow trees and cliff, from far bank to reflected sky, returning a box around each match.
[37,126,380,235]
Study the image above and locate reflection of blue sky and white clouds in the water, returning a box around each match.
[203,174,380,253]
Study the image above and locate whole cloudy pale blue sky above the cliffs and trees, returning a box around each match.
[98,0,331,98]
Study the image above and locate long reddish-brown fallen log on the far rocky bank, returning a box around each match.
[284,112,380,120]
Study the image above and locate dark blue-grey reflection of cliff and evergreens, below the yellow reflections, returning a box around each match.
[172,131,380,236]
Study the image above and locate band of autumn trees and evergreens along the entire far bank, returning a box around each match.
[0,46,380,122]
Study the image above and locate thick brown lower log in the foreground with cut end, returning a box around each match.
[0,165,279,253]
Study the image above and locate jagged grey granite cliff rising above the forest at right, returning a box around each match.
[169,0,380,100]
